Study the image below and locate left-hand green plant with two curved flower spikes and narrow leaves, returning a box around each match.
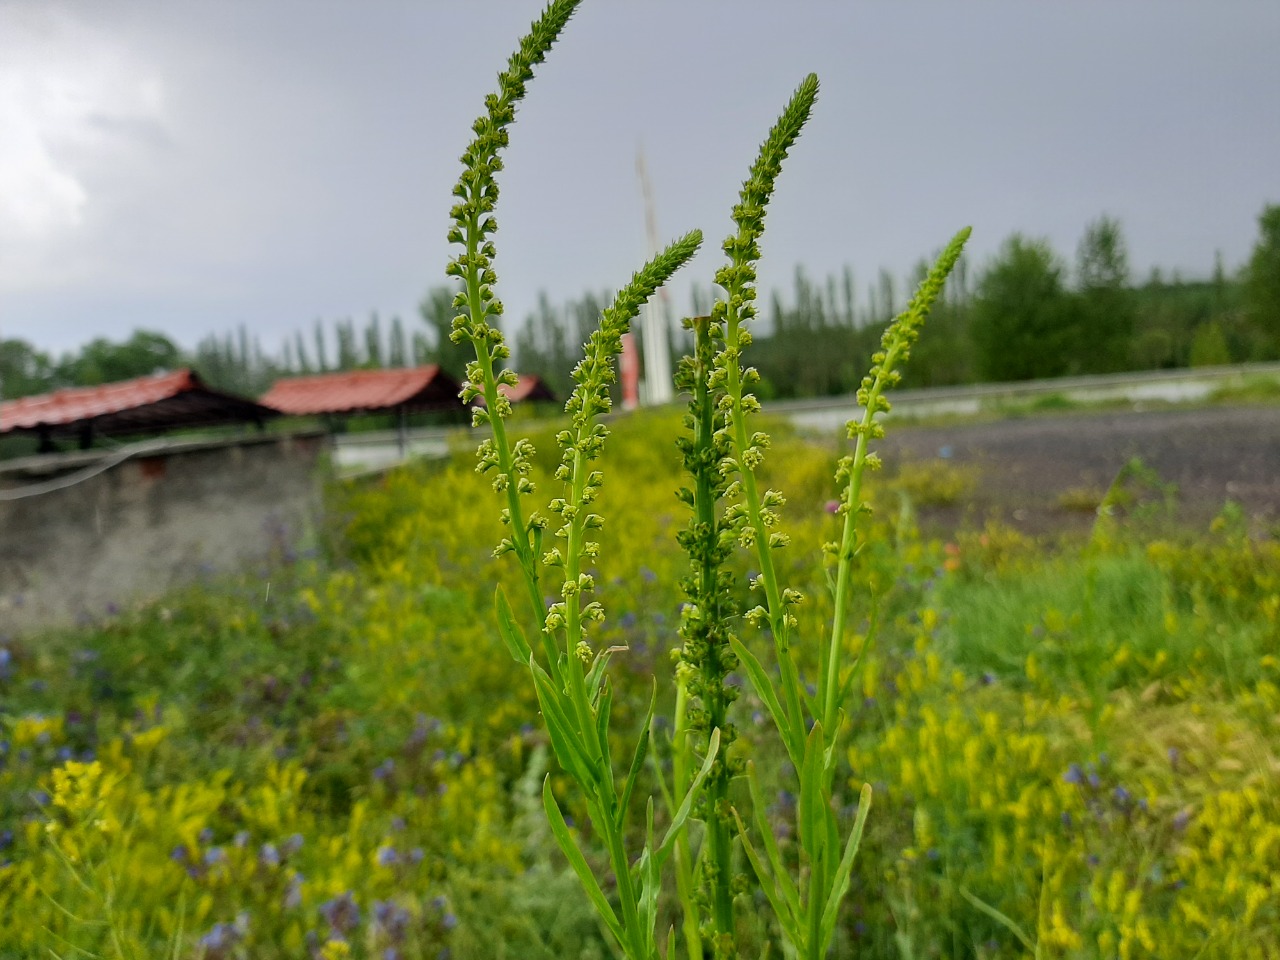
[448,0,718,960]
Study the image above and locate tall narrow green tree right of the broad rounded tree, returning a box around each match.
[1068,216,1135,374]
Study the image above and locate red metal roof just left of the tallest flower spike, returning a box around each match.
[261,364,462,416]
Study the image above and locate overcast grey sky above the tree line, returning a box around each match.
[0,0,1280,360]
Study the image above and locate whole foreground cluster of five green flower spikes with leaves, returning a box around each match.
[448,0,968,960]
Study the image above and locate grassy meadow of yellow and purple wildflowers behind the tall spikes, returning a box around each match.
[0,413,1280,960]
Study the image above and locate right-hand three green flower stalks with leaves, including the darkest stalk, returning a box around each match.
[677,74,969,957]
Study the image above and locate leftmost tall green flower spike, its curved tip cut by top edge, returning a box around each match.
[445,0,580,647]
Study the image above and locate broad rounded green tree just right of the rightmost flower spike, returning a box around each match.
[972,233,1075,380]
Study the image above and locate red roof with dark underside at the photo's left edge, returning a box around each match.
[0,370,273,434]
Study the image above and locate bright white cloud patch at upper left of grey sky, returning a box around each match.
[0,5,165,289]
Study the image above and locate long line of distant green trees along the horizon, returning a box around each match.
[0,205,1280,407]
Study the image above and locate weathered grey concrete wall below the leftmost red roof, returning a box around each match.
[0,435,328,637]
